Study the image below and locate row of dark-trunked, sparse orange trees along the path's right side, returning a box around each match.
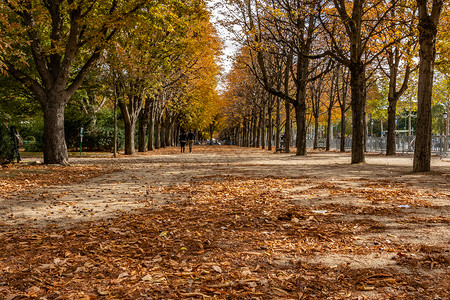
[219,0,449,171]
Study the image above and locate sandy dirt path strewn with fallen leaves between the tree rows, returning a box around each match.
[0,147,450,299]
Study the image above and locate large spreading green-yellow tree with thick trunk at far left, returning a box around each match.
[0,0,141,164]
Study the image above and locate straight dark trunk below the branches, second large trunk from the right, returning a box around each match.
[349,62,366,164]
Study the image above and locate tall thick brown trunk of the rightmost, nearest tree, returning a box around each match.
[413,0,444,172]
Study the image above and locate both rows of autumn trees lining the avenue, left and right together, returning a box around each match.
[0,0,450,172]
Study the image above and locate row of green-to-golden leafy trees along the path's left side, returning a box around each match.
[0,0,221,164]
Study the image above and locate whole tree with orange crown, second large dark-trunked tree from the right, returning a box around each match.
[320,0,406,163]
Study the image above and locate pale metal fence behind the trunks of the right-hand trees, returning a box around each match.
[306,135,450,155]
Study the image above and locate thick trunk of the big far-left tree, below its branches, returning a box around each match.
[43,96,69,165]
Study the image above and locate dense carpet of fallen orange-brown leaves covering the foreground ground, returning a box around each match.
[0,176,450,300]
